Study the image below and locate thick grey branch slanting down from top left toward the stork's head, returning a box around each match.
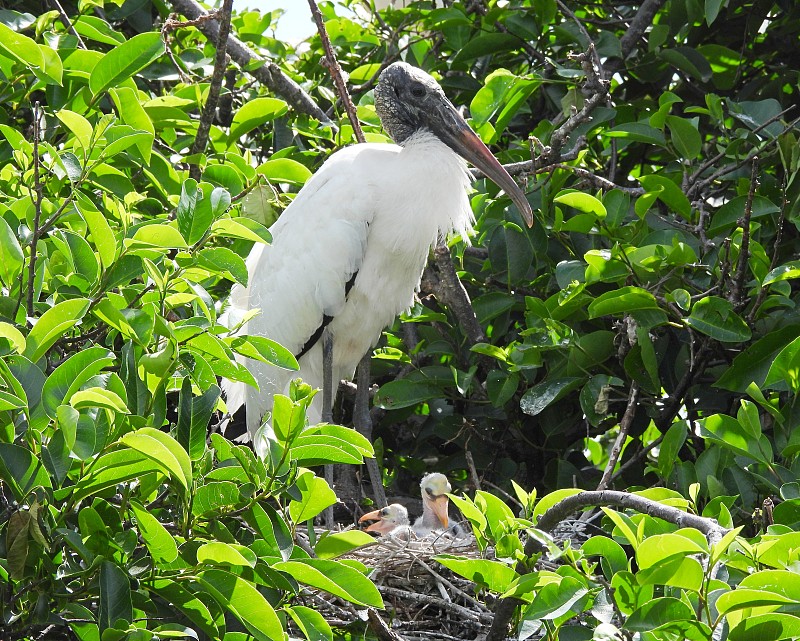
[170,0,333,125]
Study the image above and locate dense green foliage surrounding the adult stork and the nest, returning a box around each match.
[0,0,800,641]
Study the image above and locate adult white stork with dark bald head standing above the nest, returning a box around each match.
[223,62,533,436]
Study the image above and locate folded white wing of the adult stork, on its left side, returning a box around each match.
[223,145,398,434]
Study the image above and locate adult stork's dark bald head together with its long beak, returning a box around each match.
[375,62,533,227]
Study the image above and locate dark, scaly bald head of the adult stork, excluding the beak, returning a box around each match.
[375,62,455,144]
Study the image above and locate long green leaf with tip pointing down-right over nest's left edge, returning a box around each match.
[272,559,383,608]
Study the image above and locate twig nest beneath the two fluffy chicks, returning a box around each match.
[304,534,493,641]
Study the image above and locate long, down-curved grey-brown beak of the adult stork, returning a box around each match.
[429,98,533,227]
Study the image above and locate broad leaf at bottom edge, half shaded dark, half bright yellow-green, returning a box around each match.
[198,569,286,641]
